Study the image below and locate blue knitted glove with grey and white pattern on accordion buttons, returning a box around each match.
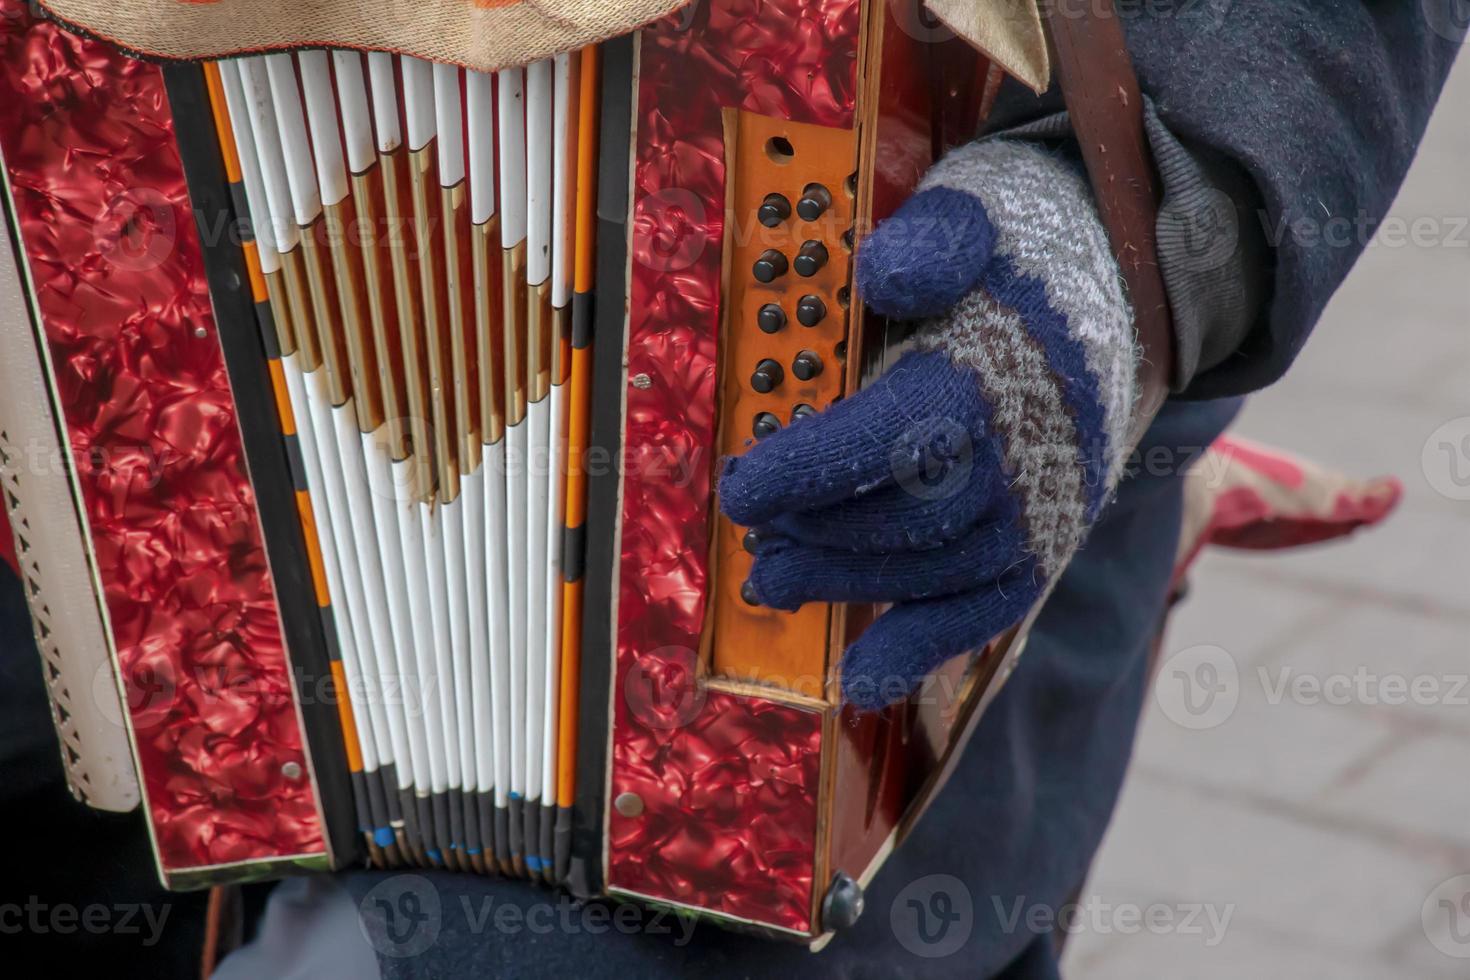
[719,141,1138,708]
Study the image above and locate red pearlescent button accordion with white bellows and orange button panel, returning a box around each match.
[0,0,1158,942]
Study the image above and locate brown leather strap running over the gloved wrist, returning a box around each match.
[1044,0,1175,444]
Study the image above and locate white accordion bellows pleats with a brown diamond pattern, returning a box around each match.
[218,50,578,873]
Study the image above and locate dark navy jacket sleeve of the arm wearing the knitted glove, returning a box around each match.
[989,0,1466,398]
